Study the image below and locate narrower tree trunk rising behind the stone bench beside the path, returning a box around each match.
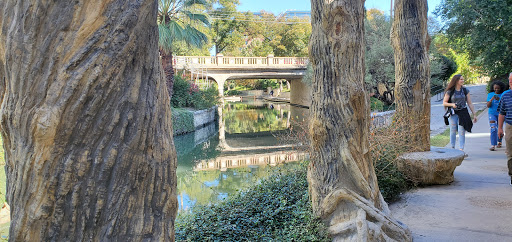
[391,0,430,151]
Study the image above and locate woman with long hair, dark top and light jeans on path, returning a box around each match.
[443,74,477,151]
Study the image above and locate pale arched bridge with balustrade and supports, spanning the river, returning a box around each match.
[173,54,311,106]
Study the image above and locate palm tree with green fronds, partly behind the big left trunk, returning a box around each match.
[157,0,210,97]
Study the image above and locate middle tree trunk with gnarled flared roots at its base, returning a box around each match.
[308,0,411,241]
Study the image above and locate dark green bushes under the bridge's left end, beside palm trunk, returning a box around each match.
[171,75,219,109]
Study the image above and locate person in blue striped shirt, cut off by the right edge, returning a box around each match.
[498,72,512,185]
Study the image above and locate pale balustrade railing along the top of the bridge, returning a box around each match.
[173,55,309,69]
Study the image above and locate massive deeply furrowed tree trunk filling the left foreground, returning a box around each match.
[0,0,177,241]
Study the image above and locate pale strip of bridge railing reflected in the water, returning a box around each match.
[194,151,308,171]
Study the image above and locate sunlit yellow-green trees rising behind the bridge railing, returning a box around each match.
[210,5,311,57]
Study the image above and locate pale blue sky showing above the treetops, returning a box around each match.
[238,0,441,15]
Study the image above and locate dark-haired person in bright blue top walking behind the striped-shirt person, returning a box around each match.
[487,81,505,151]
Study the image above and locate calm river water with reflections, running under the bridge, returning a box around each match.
[174,100,308,211]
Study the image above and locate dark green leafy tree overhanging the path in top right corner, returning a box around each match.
[436,0,512,77]
